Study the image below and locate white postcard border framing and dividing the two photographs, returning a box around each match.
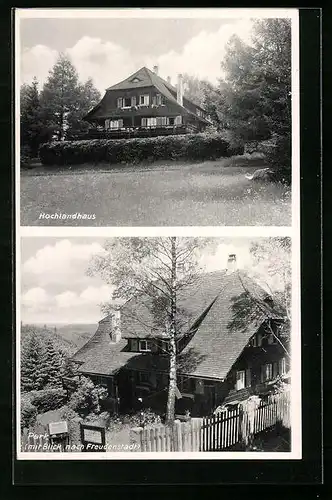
[15,8,302,461]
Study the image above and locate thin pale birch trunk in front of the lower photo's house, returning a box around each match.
[166,237,176,424]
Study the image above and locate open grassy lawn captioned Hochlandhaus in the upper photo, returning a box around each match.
[21,157,291,226]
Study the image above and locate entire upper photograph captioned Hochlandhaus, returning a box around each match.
[15,9,299,227]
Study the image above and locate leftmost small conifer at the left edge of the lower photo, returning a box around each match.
[21,333,45,392]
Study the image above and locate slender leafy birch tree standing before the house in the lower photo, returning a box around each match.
[88,237,208,423]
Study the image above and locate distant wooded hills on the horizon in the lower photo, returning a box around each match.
[21,323,97,355]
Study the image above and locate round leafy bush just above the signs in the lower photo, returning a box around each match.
[68,377,107,416]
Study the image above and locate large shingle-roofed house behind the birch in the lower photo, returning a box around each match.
[72,255,289,417]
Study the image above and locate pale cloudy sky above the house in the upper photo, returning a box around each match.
[20,17,252,94]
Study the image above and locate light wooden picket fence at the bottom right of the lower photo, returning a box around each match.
[130,393,290,452]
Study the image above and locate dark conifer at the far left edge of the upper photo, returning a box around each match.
[20,78,48,157]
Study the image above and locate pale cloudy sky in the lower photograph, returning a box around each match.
[21,237,288,324]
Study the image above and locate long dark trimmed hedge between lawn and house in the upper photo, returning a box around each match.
[39,134,244,166]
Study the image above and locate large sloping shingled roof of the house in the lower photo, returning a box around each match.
[73,271,276,379]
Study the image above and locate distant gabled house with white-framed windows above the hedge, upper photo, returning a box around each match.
[84,66,210,137]
